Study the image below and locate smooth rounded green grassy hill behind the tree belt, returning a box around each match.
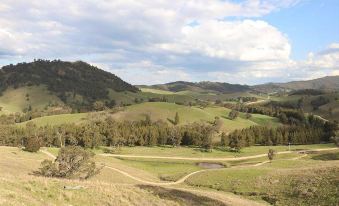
[114,102,279,131]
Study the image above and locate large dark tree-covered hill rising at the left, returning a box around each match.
[0,60,139,102]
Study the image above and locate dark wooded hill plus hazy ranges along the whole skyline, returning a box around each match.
[0,60,339,107]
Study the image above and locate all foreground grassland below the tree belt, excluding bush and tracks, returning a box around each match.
[0,144,339,205]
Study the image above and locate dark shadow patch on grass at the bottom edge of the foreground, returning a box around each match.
[138,185,226,206]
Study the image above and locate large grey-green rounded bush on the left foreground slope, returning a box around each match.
[35,146,99,179]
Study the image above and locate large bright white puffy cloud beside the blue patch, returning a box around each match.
[157,20,291,61]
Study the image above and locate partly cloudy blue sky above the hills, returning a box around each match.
[0,0,339,85]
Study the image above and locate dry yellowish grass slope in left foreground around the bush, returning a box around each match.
[0,147,236,206]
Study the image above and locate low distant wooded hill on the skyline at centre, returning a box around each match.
[141,81,250,93]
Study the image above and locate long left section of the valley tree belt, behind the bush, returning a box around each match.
[0,115,216,148]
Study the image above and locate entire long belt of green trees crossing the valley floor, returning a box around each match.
[0,112,337,151]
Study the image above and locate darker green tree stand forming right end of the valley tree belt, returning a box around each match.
[222,116,338,150]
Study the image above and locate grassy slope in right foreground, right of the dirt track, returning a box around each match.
[186,151,339,205]
